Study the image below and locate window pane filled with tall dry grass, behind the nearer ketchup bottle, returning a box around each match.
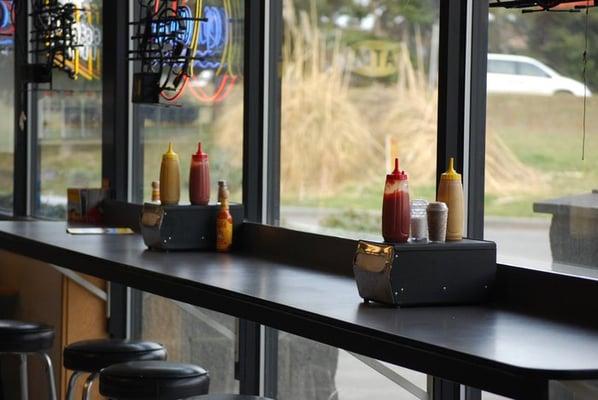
[280,0,439,239]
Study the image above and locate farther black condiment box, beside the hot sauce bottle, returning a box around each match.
[140,203,243,250]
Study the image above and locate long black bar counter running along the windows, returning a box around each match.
[0,221,598,399]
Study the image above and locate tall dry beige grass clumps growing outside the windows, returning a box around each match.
[217,0,542,200]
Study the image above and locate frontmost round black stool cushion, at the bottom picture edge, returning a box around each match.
[100,361,210,400]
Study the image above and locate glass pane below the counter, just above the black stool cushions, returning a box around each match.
[136,293,239,393]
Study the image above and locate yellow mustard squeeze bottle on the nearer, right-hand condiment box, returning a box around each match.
[436,157,465,241]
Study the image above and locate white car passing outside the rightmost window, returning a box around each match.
[488,54,592,97]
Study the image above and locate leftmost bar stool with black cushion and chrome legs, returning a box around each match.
[0,320,56,400]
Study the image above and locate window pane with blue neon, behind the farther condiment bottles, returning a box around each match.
[134,0,245,204]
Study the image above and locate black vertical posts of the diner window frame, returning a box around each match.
[6,0,591,399]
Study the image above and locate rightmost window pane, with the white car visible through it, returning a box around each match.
[485,8,598,276]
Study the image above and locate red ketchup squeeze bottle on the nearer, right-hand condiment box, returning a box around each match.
[382,158,411,243]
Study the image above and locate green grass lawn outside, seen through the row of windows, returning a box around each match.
[0,95,598,227]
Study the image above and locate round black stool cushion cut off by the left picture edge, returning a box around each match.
[0,320,54,353]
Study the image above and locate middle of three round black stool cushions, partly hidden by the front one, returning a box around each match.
[63,339,166,373]
